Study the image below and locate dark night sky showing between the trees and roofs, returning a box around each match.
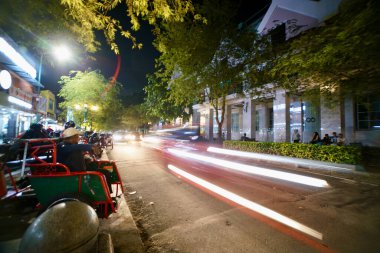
[41,0,270,100]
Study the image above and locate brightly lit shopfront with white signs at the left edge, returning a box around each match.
[0,31,43,143]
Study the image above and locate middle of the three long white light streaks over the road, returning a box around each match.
[168,148,329,187]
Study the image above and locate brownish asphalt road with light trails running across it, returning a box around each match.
[109,142,380,253]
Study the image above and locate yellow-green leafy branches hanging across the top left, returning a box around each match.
[0,0,201,53]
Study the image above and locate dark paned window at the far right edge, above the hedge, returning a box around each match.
[356,96,380,130]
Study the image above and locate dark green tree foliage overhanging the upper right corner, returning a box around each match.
[272,0,380,99]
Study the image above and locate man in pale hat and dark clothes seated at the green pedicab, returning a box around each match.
[57,127,112,193]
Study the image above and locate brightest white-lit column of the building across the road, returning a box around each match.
[273,89,290,142]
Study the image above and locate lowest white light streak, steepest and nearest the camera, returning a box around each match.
[168,164,323,240]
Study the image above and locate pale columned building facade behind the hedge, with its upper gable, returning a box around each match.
[192,0,380,147]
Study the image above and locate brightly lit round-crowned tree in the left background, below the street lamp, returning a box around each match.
[58,71,122,130]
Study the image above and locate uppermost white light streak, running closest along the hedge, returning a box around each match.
[207,147,350,170]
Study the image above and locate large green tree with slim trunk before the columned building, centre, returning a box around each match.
[153,0,256,139]
